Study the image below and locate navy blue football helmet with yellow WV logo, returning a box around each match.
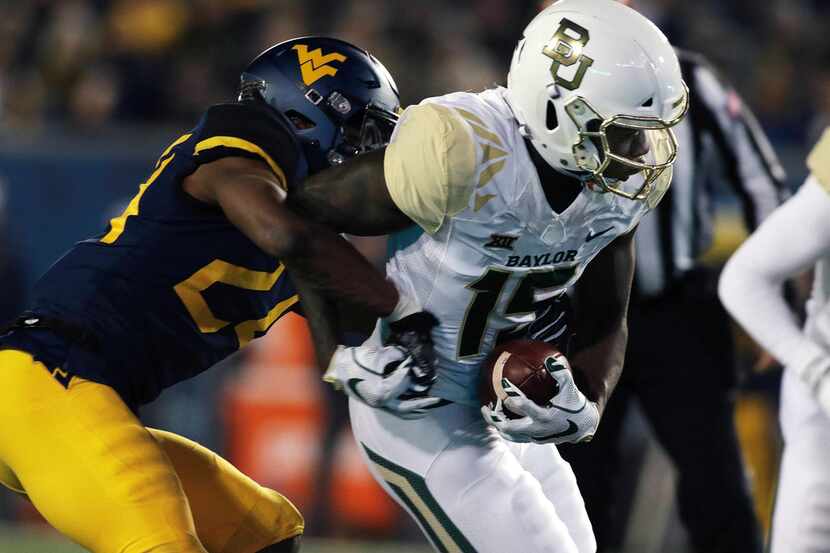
[239,36,400,173]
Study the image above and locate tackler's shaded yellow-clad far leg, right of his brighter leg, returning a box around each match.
[149,429,303,553]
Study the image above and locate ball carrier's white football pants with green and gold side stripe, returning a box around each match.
[349,400,596,553]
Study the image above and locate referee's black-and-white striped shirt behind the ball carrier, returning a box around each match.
[634,51,785,298]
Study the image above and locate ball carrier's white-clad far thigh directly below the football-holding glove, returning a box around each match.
[509,443,597,553]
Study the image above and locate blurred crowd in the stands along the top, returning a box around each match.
[0,0,830,144]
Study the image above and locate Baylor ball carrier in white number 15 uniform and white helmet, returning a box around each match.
[290,0,688,553]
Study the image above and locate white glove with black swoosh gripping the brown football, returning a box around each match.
[481,357,599,444]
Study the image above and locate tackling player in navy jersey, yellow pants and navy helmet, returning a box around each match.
[0,37,428,553]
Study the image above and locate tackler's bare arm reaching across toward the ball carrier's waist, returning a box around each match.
[184,158,398,317]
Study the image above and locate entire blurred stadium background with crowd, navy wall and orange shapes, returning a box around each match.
[0,0,830,553]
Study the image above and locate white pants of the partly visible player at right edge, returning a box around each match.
[770,370,830,553]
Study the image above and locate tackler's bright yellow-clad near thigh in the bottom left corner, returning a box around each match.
[0,350,204,553]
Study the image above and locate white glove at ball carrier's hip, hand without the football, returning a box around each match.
[323,345,442,419]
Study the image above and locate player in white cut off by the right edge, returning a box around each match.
[719,129,830,553]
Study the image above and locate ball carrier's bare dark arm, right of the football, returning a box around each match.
[571,232,634,413]
